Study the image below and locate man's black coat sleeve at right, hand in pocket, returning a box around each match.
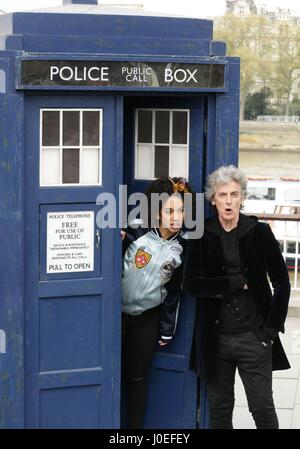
[263,223,291,332]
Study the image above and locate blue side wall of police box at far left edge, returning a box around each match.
[0,94,24,428]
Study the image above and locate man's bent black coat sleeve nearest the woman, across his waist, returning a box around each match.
[183,237,230,299]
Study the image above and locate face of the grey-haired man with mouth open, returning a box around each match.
[212,181,244,221]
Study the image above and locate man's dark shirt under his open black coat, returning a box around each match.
[219,225,263,332]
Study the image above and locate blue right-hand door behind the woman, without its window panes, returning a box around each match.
[124,96,206,429]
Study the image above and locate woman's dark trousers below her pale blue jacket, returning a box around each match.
[122,307,159,429]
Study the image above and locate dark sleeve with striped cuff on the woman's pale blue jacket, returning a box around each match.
[160,264,183,343]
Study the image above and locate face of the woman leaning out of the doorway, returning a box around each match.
[160,194,184,234]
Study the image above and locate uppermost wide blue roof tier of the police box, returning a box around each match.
[0,12,213,40]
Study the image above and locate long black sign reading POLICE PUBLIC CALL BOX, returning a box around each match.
[17,59,225,90]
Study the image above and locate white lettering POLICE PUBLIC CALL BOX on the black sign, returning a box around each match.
[50,65,198,84]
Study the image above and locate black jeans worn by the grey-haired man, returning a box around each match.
[206,331,278,429]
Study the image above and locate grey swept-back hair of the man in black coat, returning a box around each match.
[205,165,248,203]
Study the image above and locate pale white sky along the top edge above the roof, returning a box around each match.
[0,0,300,17]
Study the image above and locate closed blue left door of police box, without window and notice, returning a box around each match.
[25,96,121,428]
